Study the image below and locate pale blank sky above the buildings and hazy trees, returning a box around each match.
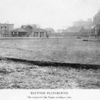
[0,0,100,30]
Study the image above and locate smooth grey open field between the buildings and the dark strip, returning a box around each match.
[0,37,100,64]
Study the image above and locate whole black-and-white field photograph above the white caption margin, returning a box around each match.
[0,0,100,99]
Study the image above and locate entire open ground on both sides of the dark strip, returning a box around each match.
[0,38,100,89]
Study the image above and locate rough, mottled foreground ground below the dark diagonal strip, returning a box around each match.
[0,60,100,89]
